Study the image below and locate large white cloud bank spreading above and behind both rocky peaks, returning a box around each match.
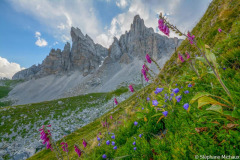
[10,0,211,47]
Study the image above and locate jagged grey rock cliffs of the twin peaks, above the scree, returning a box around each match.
[13,15,181,79]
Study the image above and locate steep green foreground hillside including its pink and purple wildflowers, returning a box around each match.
[1,0,240,160]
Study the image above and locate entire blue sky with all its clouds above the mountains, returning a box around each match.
[0,0,211,77]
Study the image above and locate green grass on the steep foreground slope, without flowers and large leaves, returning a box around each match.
[14,0,240,160]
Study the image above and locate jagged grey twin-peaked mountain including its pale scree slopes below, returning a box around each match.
[9,15,182,105]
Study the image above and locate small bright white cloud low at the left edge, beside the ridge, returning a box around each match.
[0,57,25,79]
